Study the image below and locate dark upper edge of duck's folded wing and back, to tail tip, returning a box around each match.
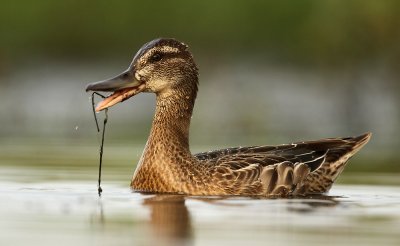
[194,133,370,171]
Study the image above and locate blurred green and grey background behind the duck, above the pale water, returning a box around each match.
[0,0,400,182]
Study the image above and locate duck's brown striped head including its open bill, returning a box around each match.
[86,38,198,111]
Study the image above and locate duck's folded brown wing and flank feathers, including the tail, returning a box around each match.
[195,134,370,194]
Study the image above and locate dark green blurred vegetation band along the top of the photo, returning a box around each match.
[0,0,400,71]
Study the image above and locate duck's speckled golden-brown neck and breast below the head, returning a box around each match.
[131,82,197,192]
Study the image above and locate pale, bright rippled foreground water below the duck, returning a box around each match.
[0,182,400,246]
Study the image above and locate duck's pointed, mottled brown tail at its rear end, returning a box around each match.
[301,132,372,194]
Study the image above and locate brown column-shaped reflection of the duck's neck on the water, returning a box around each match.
[143,195,192,245]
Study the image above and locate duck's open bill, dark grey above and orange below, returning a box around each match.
[86,72,145,112]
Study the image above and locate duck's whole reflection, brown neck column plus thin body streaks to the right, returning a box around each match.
[143,195,340,245]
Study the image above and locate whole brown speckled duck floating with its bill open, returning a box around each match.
[86,38,371,197]
